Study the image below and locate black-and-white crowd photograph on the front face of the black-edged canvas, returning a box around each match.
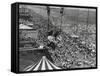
[12,4,97,72]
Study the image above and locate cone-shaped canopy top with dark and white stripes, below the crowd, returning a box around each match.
[24,56,60,71]
